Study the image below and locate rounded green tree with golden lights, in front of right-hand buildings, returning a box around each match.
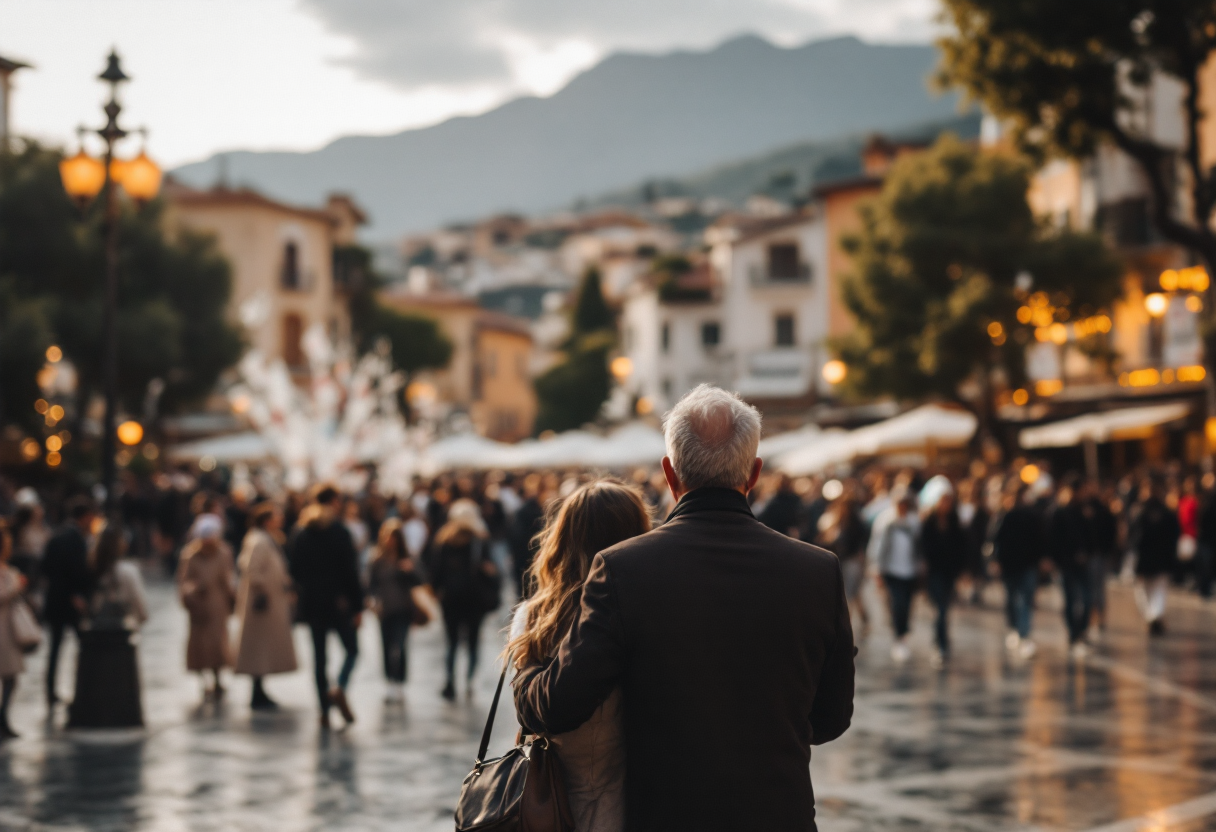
[833,135,1121,425]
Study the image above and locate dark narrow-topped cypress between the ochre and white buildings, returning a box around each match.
[534,266,617,432]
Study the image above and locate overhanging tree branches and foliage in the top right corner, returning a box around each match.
[939,0,1216,274]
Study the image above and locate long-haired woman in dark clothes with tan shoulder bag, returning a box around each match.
[368,518,422,704]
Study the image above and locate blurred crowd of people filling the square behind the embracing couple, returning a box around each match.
[0,435,1216,737]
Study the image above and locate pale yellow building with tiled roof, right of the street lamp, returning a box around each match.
[164,182,355,372]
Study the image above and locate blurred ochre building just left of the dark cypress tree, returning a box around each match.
[381,291,536,442]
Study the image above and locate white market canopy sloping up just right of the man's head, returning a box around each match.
[779,405,978,477]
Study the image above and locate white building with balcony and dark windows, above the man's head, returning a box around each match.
[621,209,832,412]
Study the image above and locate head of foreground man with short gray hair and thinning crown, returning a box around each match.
[663,384,760,491]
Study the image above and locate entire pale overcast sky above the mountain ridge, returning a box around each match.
[0,0,936,165]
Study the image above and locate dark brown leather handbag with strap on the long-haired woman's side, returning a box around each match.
[456,668,575,832]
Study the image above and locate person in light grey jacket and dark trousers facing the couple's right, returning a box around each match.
[869,488,921,664]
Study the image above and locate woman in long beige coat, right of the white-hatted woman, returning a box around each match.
[236,502,297,710]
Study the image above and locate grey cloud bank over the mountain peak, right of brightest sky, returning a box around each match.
[300,0,936,94]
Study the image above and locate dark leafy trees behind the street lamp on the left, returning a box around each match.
[0,142,242,428]
